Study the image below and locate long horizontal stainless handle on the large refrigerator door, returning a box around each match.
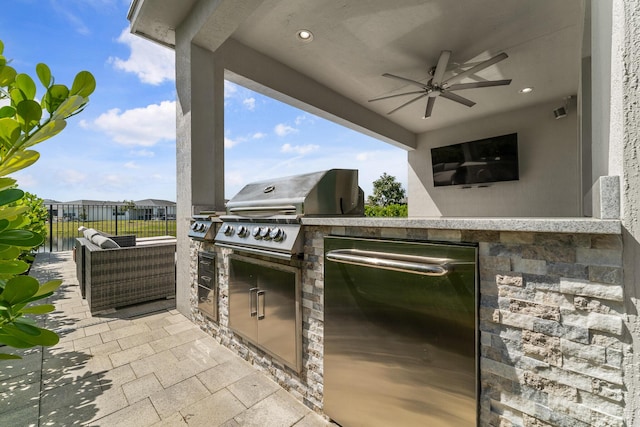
[326,249,462,276]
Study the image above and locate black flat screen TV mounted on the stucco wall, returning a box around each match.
[431,133,519,187]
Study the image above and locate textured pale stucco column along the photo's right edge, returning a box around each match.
[610,0,640,426]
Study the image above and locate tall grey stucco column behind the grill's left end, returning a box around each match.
[176,36,224,316]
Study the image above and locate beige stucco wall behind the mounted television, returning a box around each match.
[408,100,582,217]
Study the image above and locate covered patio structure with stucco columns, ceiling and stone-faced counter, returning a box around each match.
[129,0,640,427]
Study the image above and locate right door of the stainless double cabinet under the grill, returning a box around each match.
[257,268,298,366]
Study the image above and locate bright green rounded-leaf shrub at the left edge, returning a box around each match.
[0,41,96,359]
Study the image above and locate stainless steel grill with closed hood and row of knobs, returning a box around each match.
[215,169,364,259]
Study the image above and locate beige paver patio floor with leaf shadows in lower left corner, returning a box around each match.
[0,252,332,427]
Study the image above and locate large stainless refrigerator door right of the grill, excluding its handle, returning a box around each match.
[324,237,478,427]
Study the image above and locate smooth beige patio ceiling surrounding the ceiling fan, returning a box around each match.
[132,0,584,133]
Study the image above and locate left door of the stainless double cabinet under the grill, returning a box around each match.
[229,258,260,342]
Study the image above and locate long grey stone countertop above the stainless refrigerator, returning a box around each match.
[302,217,622,234]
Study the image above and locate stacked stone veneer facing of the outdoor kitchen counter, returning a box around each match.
[191,226,631,427]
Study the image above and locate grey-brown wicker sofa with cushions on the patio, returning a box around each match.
[75,231,176,313]
